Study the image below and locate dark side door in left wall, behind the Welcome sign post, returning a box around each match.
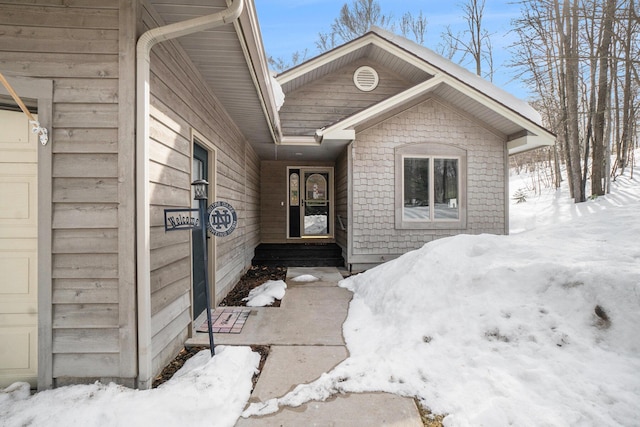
[191,144,209,319]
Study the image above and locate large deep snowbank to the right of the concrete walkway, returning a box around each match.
[243,176,640,426]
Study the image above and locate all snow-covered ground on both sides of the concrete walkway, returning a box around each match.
[0,162,640,427]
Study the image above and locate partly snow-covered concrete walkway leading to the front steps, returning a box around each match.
[187,267,422,427]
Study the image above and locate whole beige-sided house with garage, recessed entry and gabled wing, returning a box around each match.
[0,0,553,389]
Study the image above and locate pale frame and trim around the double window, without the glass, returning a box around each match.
[395,142,467,230]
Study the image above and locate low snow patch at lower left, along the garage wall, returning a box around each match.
[0,346,260,427]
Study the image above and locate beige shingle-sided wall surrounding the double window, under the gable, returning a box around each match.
[348,98,507,265]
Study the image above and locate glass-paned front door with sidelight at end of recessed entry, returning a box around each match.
[289,167,333,238]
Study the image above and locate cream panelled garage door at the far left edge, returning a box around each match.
[0,109,38,388]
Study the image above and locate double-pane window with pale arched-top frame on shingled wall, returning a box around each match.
[396,143,466,229]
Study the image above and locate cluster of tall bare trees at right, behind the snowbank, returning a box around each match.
[514,0,640,202]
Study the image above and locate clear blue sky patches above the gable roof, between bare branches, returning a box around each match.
[255,0,527,98]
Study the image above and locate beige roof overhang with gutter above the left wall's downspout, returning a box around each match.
[149,0,282,159]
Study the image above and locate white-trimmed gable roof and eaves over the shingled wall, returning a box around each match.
[277,27,555,159]
